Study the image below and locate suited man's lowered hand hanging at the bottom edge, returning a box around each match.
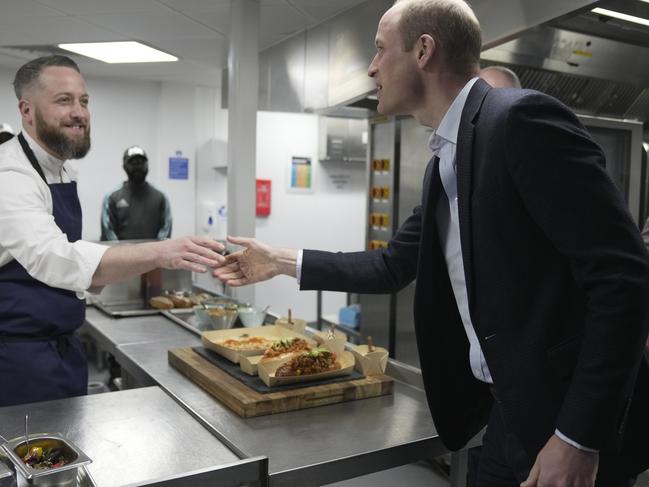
[521,435,599,487]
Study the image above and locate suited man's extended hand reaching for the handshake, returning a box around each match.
[214,237,297,287]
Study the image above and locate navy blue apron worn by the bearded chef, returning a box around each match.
[0,133,88,406]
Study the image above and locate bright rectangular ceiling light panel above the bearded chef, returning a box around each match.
[59,41,178,64]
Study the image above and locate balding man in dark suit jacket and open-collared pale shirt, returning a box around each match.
[215,0,649,487]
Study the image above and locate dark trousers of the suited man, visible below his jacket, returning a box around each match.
[468,401,635,487]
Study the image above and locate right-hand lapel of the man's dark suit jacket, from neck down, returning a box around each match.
[455,79,491,308]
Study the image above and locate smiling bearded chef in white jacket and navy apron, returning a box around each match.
[0,55,224,406]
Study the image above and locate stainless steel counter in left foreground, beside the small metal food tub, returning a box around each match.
[0,387,266,487]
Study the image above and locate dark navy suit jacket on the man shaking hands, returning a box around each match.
[301,80,649,473]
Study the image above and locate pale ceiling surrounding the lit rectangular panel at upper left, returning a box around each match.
[0,0,365,86]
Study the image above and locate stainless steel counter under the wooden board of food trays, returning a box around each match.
[81,309,460,487]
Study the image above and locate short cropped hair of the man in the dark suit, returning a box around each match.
[394,0,482,75]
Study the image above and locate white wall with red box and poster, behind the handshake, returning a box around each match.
[255,112,366,321]
